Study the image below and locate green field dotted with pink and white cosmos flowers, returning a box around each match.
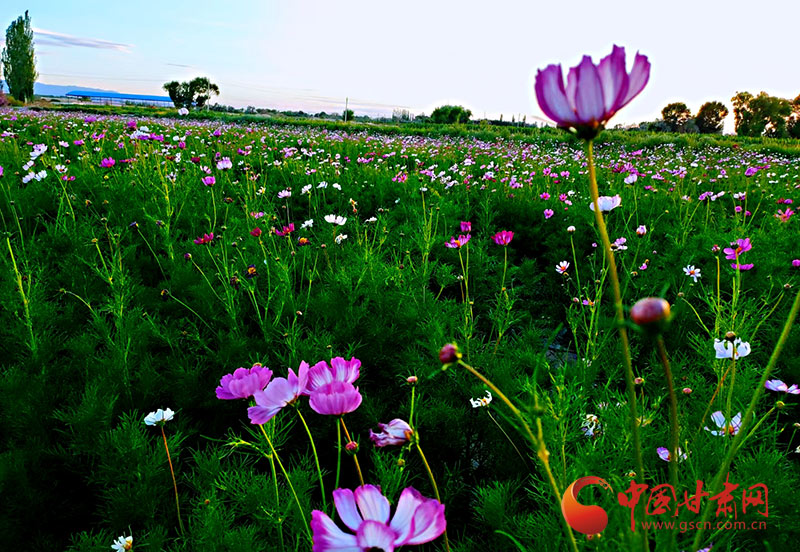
[0,104,800,552]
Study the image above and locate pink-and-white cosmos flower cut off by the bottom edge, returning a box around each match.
[311,485,447,552]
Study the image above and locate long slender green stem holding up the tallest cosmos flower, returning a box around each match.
[586,140,649,550]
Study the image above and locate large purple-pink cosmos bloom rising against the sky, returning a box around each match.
[535,46,650,139]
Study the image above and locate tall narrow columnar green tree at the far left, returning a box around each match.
[1,11,39,102]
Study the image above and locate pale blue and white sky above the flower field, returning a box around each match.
[0,0,800,132]
